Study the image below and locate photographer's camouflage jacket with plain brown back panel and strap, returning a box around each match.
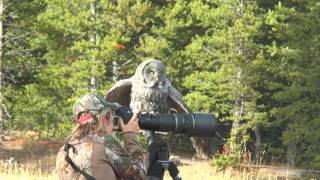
[56,132,146,180]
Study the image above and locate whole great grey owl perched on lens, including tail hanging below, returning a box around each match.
[105,60,209,157]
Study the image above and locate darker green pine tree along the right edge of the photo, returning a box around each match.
[267,1,320,167]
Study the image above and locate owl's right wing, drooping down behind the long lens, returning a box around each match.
[168,86,191,113]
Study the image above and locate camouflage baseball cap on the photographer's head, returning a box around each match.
[73,94,120,119]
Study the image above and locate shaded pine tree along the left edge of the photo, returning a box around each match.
[1,0,45,134]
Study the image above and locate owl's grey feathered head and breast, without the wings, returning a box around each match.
[130,60,171,113]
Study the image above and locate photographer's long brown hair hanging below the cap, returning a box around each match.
[67,111,113,140]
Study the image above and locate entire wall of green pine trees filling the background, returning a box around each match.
[1,0,320,168]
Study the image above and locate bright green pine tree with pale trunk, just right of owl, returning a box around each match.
[183,1,266,160]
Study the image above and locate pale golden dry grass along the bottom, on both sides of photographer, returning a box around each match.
[0,156,279,180]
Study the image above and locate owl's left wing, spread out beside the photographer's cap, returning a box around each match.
[105,78,132,107]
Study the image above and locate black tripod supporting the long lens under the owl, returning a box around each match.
[147,131,182,180]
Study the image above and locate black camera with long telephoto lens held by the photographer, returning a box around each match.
[113,106,218,137]
